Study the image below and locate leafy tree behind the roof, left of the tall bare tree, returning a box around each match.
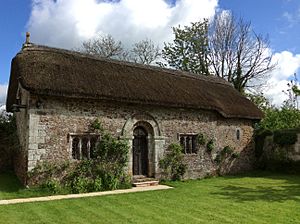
[162,19,209,75]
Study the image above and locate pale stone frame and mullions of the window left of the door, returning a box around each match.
[68,132,100,160]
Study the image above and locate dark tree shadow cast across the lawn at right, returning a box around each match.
[212,174,300,202]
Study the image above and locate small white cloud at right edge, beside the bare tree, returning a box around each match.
[264,51,300,106]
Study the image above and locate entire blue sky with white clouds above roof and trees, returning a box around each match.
[0,0,300,105]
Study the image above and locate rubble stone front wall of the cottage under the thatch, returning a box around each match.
[17,91,254,184]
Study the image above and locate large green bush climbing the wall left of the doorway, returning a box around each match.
[67,133,130,193]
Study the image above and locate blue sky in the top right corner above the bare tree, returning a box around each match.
[219,0,300,53]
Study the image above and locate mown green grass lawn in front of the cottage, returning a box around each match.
[0,173,300,224]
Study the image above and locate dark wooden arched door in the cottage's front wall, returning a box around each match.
[132,126,148,176]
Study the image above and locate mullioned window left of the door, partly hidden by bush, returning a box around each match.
[70,133,99,160]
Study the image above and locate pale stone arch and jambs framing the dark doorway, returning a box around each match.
[121,113,165,177]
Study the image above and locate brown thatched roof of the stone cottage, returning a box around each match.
[7,44,262,119]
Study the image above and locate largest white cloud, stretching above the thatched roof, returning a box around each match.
[27,0,218,48]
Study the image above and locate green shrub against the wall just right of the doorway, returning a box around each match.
[159,143,187,180]
